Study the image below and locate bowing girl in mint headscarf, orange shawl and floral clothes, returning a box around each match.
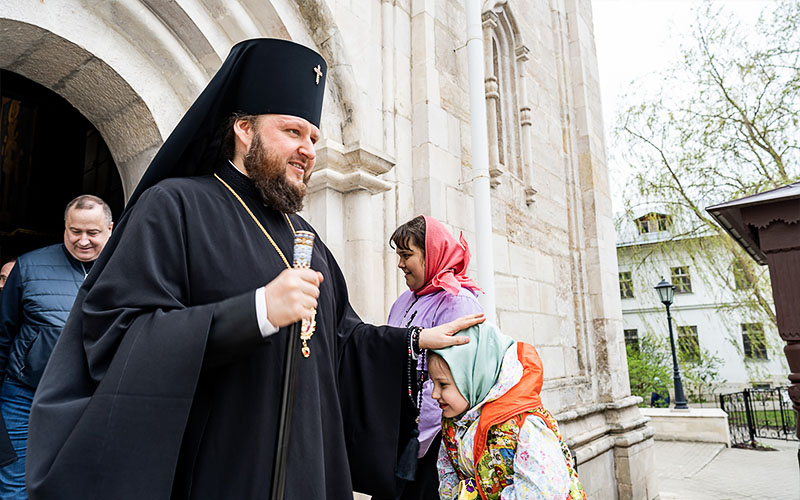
[428,323,586,500]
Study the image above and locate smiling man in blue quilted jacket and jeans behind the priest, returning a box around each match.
[0,195,114,500]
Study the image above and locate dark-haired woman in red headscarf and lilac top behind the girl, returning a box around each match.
[388,215,483,500]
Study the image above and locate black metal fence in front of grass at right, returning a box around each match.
[719,387,798,446]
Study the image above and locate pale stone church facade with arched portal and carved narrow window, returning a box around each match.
[0,0,658,499]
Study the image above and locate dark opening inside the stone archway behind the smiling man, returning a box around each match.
[0,70,124,262]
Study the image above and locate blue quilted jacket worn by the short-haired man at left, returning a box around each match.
[0,244,91,389]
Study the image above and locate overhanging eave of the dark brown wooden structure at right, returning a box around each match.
[706,182,800,266]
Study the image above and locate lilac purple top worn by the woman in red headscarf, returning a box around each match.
[388,288,483,458]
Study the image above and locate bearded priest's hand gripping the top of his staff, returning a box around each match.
[264,269,323,328]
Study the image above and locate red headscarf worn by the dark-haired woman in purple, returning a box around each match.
[413,215,483,295]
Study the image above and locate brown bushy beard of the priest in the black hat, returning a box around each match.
[244,134,307,214]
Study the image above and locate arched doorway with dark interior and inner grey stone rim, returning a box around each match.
[0,18,162,260]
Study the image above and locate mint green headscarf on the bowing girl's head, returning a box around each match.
[433,323,514,408]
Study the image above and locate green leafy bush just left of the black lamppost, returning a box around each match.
[626,336,672,406]
